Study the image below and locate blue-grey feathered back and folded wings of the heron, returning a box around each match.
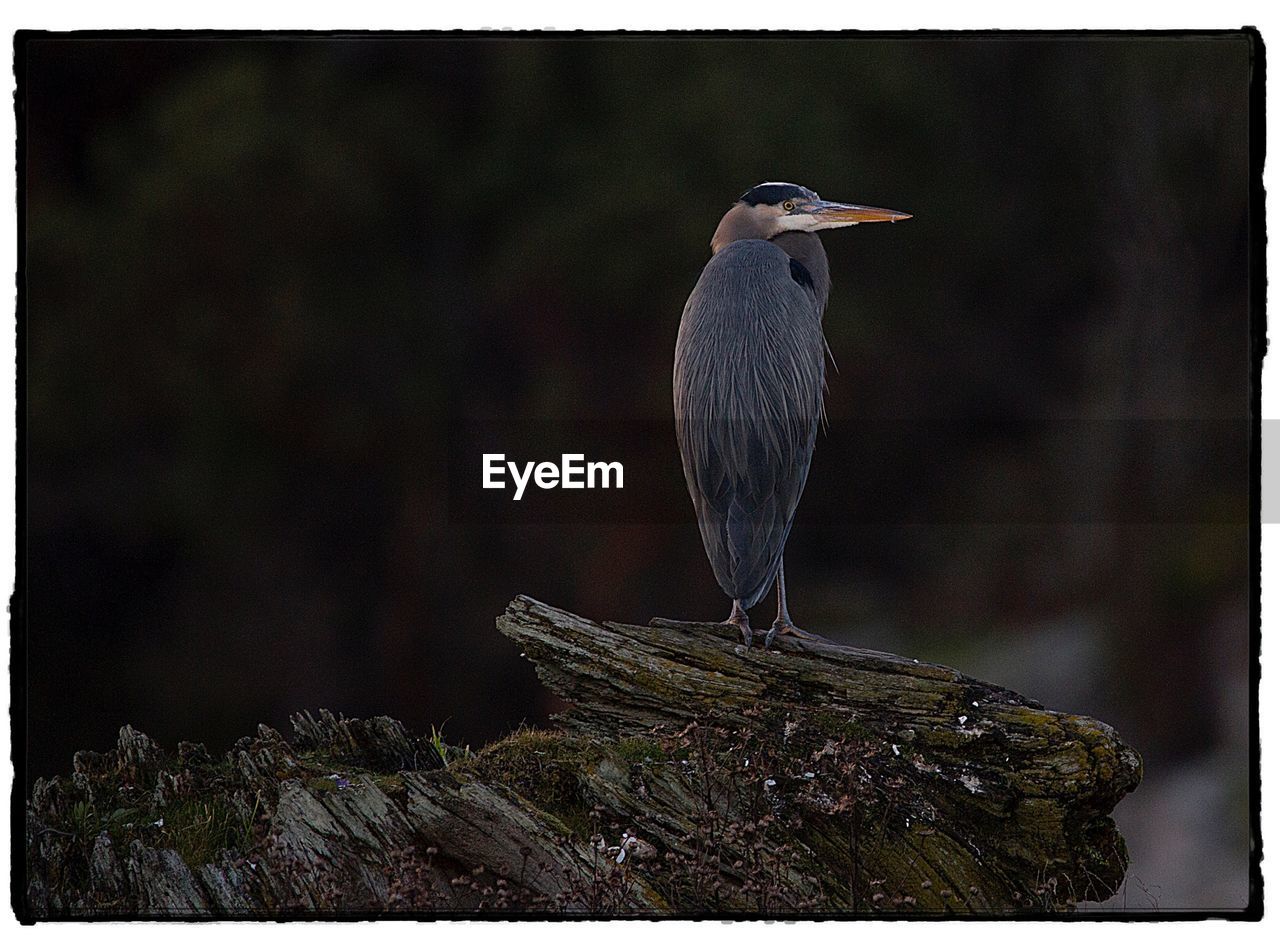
[675,239,826,607]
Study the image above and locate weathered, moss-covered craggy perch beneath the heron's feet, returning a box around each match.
[15,596,1142,919]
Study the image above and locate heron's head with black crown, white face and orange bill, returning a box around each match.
[712,183,911,252]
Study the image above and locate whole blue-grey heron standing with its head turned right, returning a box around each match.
[673,183,910,648]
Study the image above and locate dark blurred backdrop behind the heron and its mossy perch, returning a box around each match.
[19,36,1251,910]
